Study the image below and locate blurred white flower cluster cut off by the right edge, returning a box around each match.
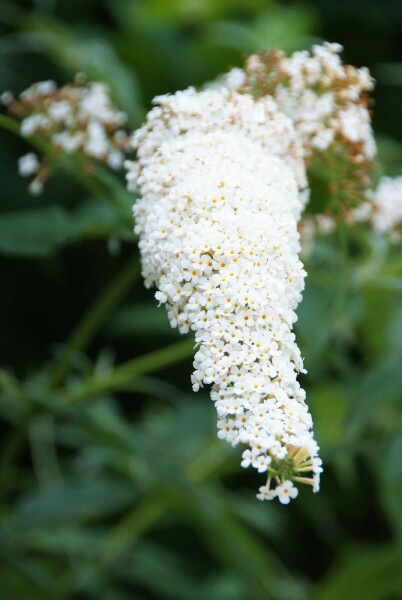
[353,177,402,241]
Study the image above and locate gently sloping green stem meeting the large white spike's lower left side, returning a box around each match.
[61,339,194,405]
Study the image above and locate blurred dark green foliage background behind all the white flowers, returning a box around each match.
[0,0,402,600]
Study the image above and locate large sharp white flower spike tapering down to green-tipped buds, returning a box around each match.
[127,88,322,504]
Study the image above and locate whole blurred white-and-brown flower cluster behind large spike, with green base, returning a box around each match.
[224,43,376,215]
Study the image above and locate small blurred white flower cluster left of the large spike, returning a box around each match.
[1,76,128,194]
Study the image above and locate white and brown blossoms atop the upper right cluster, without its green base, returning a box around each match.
[224,43,376,161]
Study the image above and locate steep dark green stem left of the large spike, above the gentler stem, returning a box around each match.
[50,257,140,386]
